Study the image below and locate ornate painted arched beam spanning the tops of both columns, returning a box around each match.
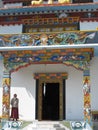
[2,48,93,72]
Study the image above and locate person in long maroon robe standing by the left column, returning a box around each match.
[11,94,19,121]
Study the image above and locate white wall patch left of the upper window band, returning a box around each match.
[0,25,22,34]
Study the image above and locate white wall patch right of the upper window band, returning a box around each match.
[80,22,98,31]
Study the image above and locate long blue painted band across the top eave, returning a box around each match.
[0,3,98,14]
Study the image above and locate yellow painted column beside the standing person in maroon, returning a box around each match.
[2,69,11,119]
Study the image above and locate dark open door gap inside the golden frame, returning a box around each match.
[42,83,59,120]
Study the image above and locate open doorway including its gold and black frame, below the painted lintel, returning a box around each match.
[36,79,65,120]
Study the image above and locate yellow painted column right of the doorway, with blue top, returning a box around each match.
[83,67,92,126]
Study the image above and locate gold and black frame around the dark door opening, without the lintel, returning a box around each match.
[36,78,65,120]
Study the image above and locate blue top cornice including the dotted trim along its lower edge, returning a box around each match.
[0,3,98,16]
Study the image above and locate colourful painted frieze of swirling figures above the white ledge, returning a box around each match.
[0,31,98,47]
